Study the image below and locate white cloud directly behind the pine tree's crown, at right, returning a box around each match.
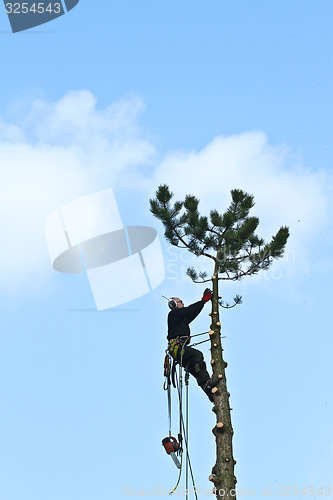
[151,131,332,290]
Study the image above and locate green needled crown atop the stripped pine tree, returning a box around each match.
[150,185,289,281]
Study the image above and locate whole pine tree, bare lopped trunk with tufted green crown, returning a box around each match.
[150,185,289,500]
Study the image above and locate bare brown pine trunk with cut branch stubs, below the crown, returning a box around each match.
[209,268,236,500]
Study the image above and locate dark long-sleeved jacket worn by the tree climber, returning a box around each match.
[168,300,205,340]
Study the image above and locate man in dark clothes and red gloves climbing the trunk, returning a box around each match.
[168,288,220,403]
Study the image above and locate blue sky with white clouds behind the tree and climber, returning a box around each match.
[0,0,333,500]
